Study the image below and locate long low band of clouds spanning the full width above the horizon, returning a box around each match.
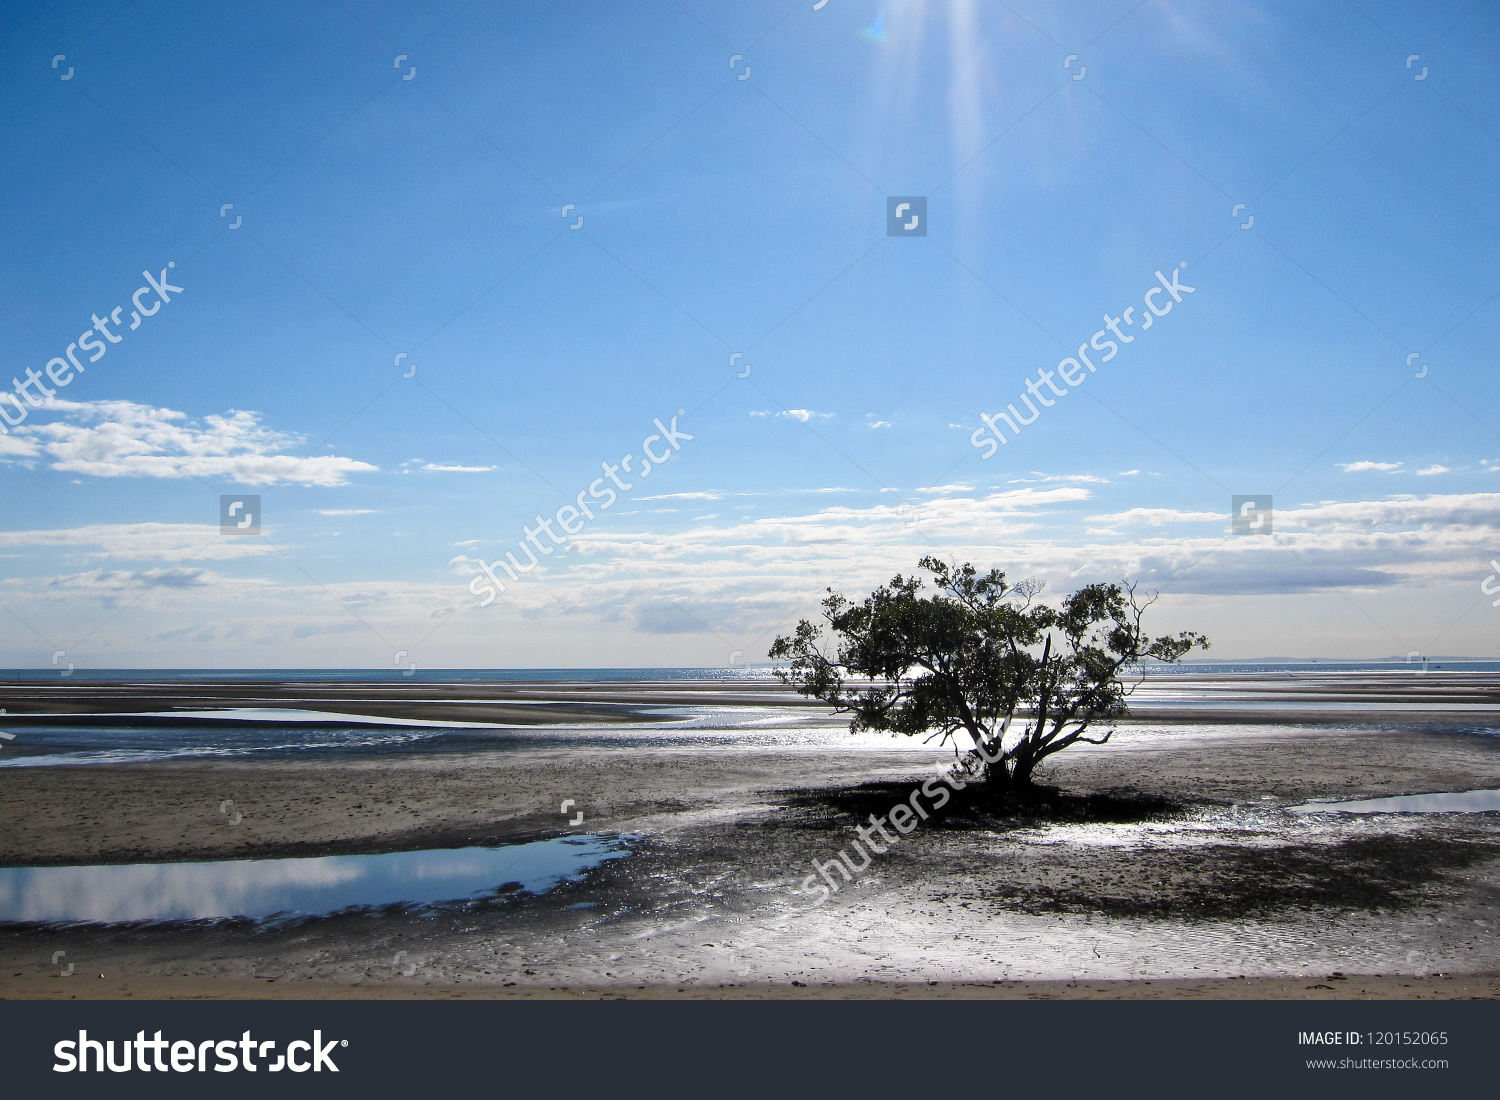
[11,485,1500,660]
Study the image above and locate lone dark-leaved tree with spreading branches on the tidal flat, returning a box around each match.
[770,557,1209,795]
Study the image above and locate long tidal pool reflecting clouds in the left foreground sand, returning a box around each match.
[0,836,629,923]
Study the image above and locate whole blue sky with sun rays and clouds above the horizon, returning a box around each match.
[0,0,1500,668]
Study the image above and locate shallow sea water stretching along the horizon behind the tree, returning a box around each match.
[0,659,1500,768]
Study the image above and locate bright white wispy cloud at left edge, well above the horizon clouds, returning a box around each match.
[3,398,377,486]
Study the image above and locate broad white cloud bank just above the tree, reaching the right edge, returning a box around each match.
[528,486,1500,633]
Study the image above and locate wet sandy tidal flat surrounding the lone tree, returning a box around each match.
[0,674,1500,998]
